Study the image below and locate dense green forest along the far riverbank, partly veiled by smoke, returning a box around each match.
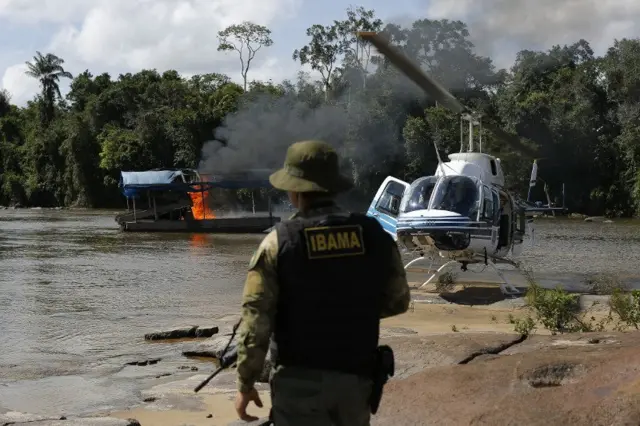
[0,8,640,216]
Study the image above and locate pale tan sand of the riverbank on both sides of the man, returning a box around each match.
[110,285,576,426]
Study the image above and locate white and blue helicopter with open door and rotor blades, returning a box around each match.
[358,32,566,296]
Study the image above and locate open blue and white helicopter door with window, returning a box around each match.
[367,176,409,240]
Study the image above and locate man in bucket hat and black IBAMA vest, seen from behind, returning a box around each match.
[236,141,410,426]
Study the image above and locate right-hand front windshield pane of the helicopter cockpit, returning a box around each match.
[431,176,482,220]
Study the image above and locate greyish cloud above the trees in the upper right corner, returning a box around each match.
[426,0,640,66]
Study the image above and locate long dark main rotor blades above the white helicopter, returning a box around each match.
[357,31,535,157]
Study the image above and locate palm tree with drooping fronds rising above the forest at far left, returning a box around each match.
[26,52,73,124]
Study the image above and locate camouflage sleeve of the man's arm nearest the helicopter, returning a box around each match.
[380,238,411,318]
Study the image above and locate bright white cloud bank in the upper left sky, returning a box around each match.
[0,0,302,102]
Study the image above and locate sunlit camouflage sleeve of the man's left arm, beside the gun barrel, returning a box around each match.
[237,230,278,393]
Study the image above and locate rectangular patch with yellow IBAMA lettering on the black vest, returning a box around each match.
[304,225,364,259]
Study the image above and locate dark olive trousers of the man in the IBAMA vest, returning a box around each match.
[271,366,372,426]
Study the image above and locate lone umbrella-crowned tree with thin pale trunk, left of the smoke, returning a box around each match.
[218,21,273,92]
